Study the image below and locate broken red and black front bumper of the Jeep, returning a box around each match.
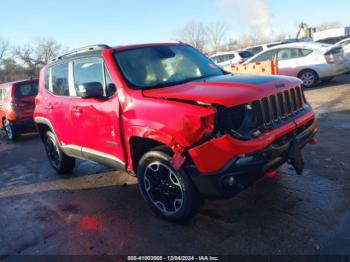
[188,111,318,199]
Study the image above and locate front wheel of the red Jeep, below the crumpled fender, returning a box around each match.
[137,149,204,223]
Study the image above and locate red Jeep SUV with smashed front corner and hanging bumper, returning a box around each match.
[35,43,317,222]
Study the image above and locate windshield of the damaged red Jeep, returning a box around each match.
[114,45,223,89]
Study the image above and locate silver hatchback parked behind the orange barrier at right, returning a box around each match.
[246,42,348,87]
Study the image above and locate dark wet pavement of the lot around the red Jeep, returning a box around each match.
[0,75,350,259]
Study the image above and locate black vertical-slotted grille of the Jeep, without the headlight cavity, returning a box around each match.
[252,87,305,126]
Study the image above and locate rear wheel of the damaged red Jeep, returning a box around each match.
[44,131,75,174]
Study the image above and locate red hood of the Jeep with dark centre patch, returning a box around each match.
[143,75,301,107]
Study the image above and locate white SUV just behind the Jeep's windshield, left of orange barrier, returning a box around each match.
[209,51,254,68]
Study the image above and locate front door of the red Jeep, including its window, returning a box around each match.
[70,57,125,166]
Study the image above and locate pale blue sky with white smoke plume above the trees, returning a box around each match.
[0,0,350,48]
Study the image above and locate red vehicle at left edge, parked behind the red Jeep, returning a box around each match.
[0,79,38,141]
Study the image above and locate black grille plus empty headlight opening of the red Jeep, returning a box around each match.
[216,87,306,139]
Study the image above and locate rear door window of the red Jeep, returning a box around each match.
[51,63,69,96]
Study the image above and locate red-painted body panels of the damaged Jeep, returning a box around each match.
[35,43,316,178]
